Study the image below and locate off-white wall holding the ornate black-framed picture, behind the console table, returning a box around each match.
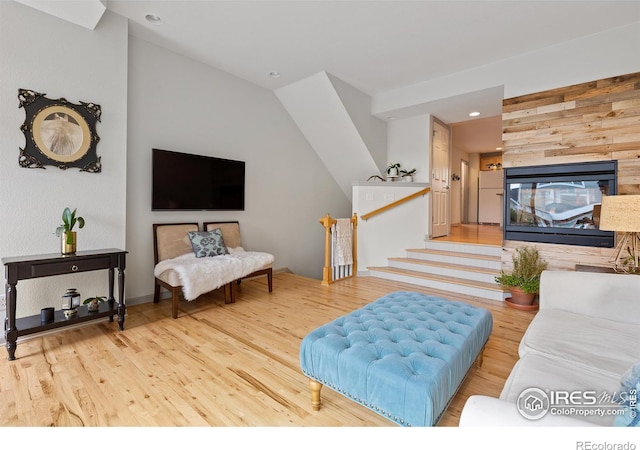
[0,1,127,316]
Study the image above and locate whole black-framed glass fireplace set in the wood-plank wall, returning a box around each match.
[504,161,617,248]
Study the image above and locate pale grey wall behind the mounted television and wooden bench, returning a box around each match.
[127,37,351,298]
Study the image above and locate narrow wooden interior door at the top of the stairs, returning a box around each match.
[431,119,451,237]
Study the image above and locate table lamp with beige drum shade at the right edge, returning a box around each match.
[600,195,640,274]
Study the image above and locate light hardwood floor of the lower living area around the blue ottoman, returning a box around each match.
[0,273,535,427]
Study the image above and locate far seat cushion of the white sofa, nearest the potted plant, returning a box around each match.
[519,309,640,380]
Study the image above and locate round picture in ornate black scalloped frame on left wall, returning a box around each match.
[18,89,102,173]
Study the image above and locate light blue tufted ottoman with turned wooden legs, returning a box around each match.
[300,292,493,426]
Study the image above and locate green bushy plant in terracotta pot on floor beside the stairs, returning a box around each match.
[495,247,548,305]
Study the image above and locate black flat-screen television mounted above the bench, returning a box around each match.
[151,148,245,211]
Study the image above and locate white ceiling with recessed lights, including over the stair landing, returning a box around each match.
[18,0,640,151]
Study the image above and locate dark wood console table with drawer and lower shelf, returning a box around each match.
[2,248,127,361]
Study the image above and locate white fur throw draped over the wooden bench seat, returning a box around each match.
[153,248,274,301]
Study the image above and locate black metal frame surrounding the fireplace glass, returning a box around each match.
[503,161,618,248]
